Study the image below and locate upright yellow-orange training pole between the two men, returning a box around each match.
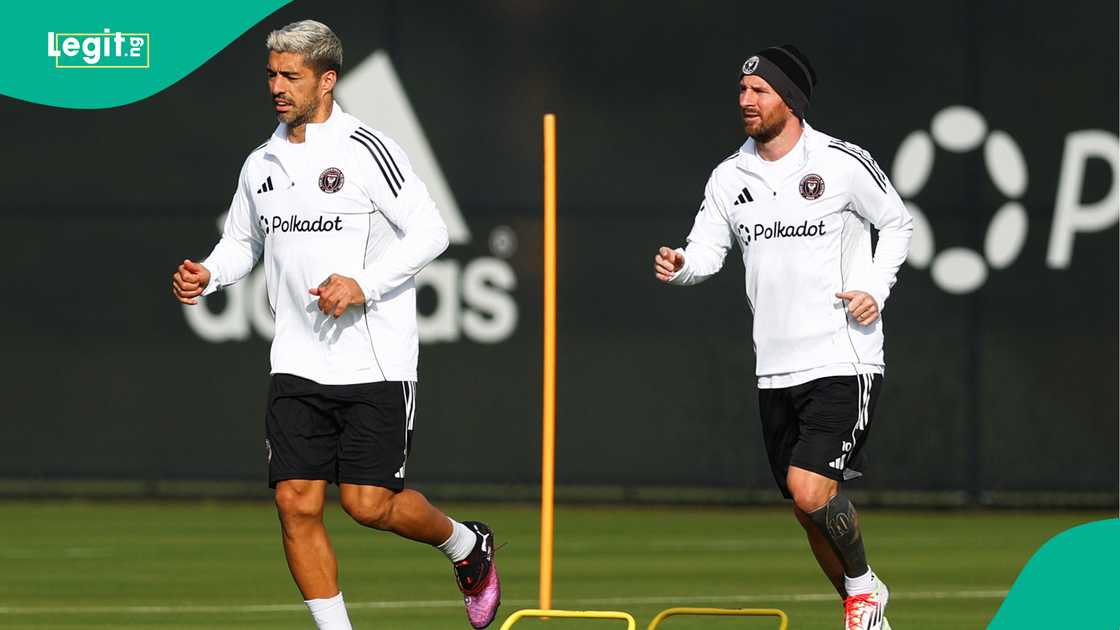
[541,113,557,610]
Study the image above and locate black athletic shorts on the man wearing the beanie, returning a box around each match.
[758,374,883,499]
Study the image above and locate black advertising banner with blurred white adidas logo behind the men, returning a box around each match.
[0,1,1120,498]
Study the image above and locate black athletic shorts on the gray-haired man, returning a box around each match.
[264,374,416,490]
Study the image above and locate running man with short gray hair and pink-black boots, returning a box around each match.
[171,20,501,630]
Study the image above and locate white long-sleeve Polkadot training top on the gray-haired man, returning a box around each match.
[203,103,448,385]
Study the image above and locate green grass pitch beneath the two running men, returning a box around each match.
[0,501,1111,630]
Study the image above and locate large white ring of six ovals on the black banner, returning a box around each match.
[892,105,1027,294]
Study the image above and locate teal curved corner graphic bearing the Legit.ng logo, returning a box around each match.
[0,0,291,109]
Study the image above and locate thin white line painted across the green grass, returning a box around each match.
[0,590,1007,614]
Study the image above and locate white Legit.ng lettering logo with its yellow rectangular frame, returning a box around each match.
[47,28,151,70]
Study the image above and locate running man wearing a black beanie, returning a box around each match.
[654,44,913,630]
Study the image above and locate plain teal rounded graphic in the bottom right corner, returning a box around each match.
[988,519,1120,630]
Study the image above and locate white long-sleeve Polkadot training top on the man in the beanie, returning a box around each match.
[671,122,913,388]
